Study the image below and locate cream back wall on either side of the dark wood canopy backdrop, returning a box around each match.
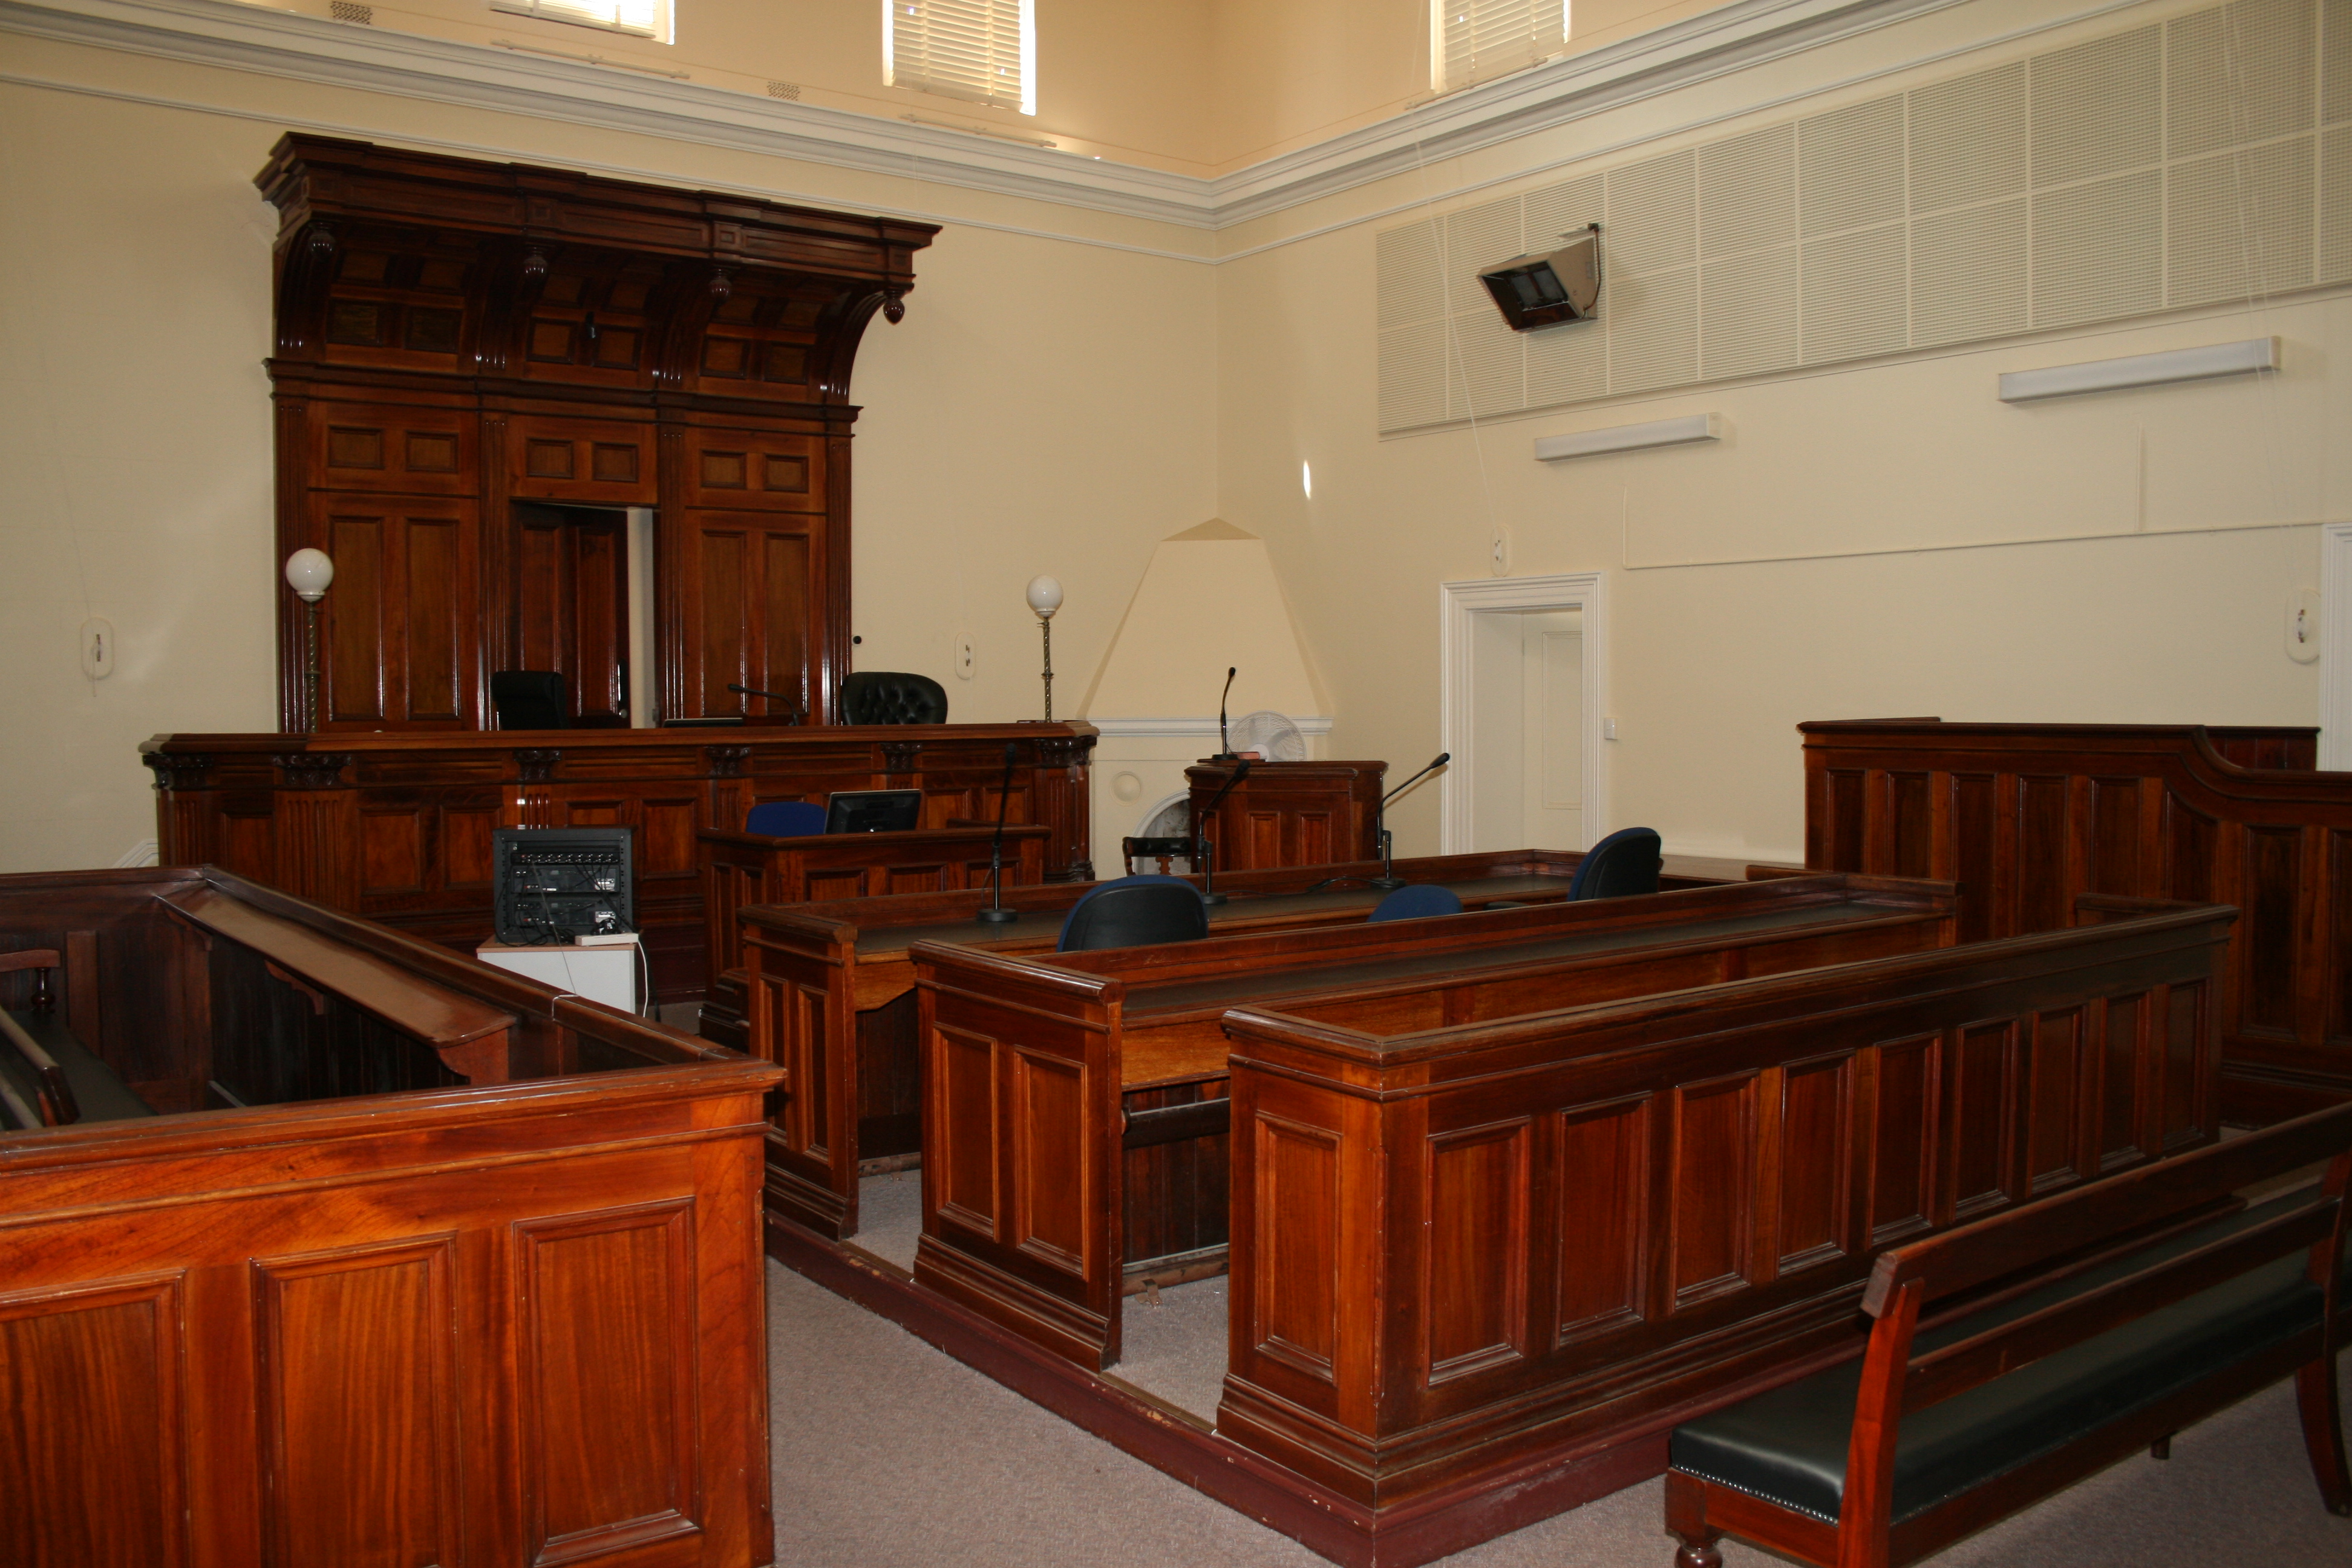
[0,38,1216,870]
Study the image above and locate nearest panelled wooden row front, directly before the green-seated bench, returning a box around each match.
[1214,905,2230,1507]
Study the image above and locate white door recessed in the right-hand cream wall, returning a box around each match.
[1470,609,1586,849]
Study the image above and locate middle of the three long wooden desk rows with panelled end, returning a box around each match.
[907,877,1952,1366]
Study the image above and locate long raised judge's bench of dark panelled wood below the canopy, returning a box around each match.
[139,724,1094,1001]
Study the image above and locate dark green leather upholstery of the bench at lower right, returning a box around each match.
[1668,1192,2324,1523]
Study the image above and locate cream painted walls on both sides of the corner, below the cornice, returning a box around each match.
[0,0,2352,870]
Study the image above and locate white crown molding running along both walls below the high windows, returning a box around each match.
[0,0,1966,228]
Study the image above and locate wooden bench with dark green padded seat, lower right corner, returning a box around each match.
[1665,1105,2352,1568]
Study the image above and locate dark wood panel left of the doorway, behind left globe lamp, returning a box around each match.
[313,494,480,729]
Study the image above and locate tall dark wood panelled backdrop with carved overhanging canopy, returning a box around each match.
[256,134,936,731]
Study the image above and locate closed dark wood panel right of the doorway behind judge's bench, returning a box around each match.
[675,508,826,717]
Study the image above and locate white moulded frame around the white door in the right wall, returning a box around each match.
[1437,571,1609,856]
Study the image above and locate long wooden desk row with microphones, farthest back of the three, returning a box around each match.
[738,849,1753,1236]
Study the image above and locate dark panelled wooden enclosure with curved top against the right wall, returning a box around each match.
[1802,719,2352,1124]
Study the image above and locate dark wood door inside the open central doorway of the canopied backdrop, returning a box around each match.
[513,501,628,727]
